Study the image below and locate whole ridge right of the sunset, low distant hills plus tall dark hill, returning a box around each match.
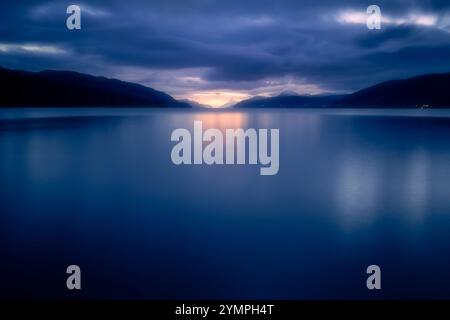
[234,73,450,108]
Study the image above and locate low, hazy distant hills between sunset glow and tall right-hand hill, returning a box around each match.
[234,93,344,108]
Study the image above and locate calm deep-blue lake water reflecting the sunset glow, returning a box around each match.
[0,109,450,299]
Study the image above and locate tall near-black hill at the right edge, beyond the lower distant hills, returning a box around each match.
[339,73,450,107]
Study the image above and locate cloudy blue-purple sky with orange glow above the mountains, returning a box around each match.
[0,0,450,107]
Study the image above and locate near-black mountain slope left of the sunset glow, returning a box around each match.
[0,68,191,108]
